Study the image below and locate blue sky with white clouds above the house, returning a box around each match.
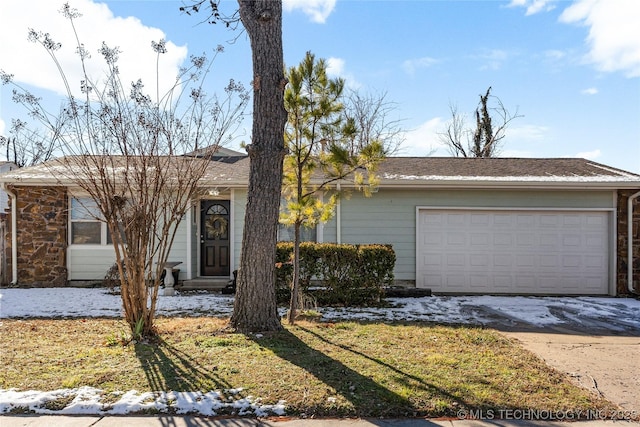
[0,0,640,173]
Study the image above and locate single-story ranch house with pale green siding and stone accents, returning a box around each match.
[0,155,640,295]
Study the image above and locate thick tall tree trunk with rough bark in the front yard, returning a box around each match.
[231,0,287,332]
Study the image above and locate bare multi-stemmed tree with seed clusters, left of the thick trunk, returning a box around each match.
[2,5,249,336]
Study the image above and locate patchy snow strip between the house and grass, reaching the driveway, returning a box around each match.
[0,288,640,328]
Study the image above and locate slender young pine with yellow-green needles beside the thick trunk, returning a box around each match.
[280,52,384,324]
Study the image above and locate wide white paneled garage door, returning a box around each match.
[416,209,609,295]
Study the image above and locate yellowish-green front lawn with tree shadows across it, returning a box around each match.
[0,318,614,417]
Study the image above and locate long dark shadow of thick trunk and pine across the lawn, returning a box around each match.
[250,326,466,417]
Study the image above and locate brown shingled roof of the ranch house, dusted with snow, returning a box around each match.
[0,155,640,188]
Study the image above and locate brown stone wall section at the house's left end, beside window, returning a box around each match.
[5,186,68,287]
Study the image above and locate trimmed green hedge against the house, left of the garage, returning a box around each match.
[276,242,396,306]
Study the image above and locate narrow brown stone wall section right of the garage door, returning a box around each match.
[617,188,640,295]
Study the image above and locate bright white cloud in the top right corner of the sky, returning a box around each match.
[560,0,640,77]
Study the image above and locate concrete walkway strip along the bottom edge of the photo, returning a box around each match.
[0,415,640,427]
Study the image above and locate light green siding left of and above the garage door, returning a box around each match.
[336,189,615,281]
